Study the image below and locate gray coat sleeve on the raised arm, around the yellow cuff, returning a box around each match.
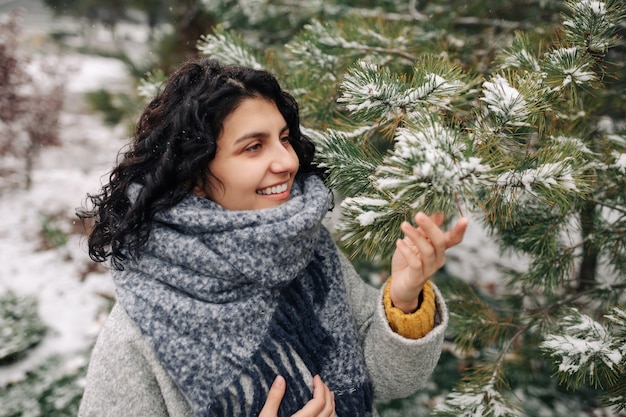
[339,249,448,400]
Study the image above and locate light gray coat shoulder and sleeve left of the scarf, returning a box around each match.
[78,305,193,417]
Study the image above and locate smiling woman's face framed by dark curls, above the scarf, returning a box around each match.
[195,98,299,210]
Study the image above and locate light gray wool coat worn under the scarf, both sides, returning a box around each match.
[78,249,448,417]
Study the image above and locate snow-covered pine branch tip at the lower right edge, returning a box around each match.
[540,308,626,386]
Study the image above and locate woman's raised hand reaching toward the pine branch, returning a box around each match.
[389,212,468,313]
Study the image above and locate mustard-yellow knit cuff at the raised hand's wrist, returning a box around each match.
[383,278,436,339]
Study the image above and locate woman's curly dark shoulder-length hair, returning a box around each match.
[77,58,323,269]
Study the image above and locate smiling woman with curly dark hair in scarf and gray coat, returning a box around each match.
[79,59,467,417]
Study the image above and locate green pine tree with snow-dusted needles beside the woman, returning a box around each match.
[190,0,626,416]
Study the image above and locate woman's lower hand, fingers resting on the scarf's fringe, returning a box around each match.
[259,375,335,417]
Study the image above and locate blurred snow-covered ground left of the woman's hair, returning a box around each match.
[0,52,126,386]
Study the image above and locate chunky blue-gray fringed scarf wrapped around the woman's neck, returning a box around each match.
[113,176,373,416]
